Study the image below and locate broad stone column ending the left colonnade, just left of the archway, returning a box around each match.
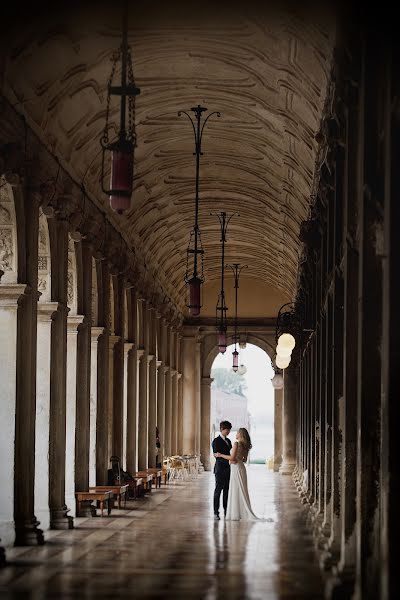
[182,328,197,454]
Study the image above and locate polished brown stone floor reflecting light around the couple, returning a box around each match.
[0,465,323,600]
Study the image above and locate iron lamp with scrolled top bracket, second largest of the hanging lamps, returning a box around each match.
[178,104,221,317]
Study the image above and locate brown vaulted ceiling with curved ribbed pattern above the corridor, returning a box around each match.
[1,2,334,316]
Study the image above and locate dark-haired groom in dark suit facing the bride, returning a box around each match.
[212,421,232,521]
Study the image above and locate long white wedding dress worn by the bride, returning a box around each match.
[225,442,260,521]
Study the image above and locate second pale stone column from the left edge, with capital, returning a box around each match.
[35,302,58,529]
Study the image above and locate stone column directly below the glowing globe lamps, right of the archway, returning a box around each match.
[279,367,297,475]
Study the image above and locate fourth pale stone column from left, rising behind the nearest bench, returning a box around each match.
[89,327,104,485]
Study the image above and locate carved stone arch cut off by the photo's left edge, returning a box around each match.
[0,175,18,284]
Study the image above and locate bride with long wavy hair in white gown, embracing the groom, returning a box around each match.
[215,427,258,521]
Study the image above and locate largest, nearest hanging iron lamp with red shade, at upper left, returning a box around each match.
[100,2,140,214]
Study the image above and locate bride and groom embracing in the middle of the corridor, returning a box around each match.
[212,421,258,521]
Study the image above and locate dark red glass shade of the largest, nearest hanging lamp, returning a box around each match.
[110,143,133,213]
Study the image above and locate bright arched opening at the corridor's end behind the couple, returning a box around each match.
[210,343,275,469]
